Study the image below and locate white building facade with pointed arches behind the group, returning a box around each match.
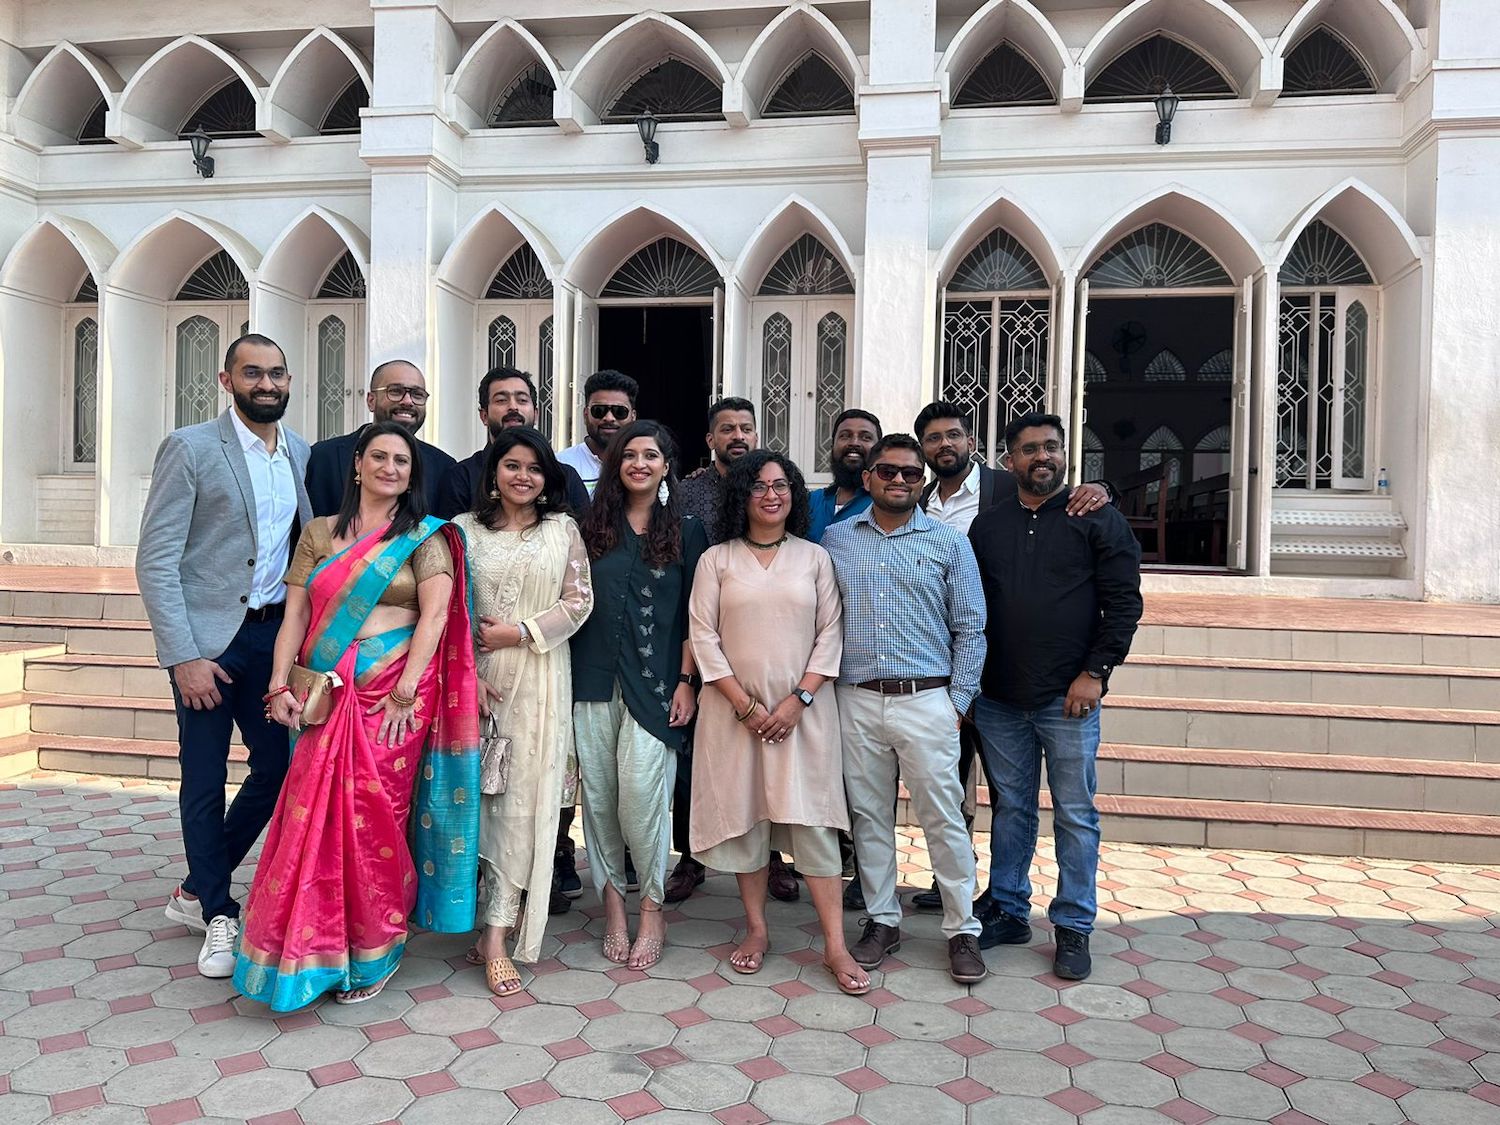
[0,0,1500,602]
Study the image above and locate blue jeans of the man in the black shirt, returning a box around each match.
[974,696,1100,933]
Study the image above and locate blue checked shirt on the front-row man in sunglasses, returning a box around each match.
[822,509,986,714]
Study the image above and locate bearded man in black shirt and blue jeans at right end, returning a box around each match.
[969,414,1142,981]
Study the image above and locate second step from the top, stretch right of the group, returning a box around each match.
[1110,653,1500,711]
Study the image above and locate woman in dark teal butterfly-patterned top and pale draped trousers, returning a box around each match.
[573,422,708,969]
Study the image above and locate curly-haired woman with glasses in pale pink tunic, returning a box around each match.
[690,450,870,996]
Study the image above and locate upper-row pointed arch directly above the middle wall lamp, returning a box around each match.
[560,12,732,128]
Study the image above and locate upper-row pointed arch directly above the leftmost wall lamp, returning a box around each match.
[105,35,266,143]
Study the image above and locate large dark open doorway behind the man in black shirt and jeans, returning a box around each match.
[1083,294,1235,567]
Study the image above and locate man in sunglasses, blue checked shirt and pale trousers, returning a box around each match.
[822,434,986,984]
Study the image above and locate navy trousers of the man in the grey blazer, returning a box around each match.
[168,617,290,921]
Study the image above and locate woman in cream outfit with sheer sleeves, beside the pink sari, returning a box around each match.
[453,426,594,996]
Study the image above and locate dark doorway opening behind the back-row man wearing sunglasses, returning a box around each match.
[599,305,714,476]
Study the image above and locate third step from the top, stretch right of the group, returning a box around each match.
[1103,692,1500,762]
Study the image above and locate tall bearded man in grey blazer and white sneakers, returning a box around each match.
[135,333,312,977]
